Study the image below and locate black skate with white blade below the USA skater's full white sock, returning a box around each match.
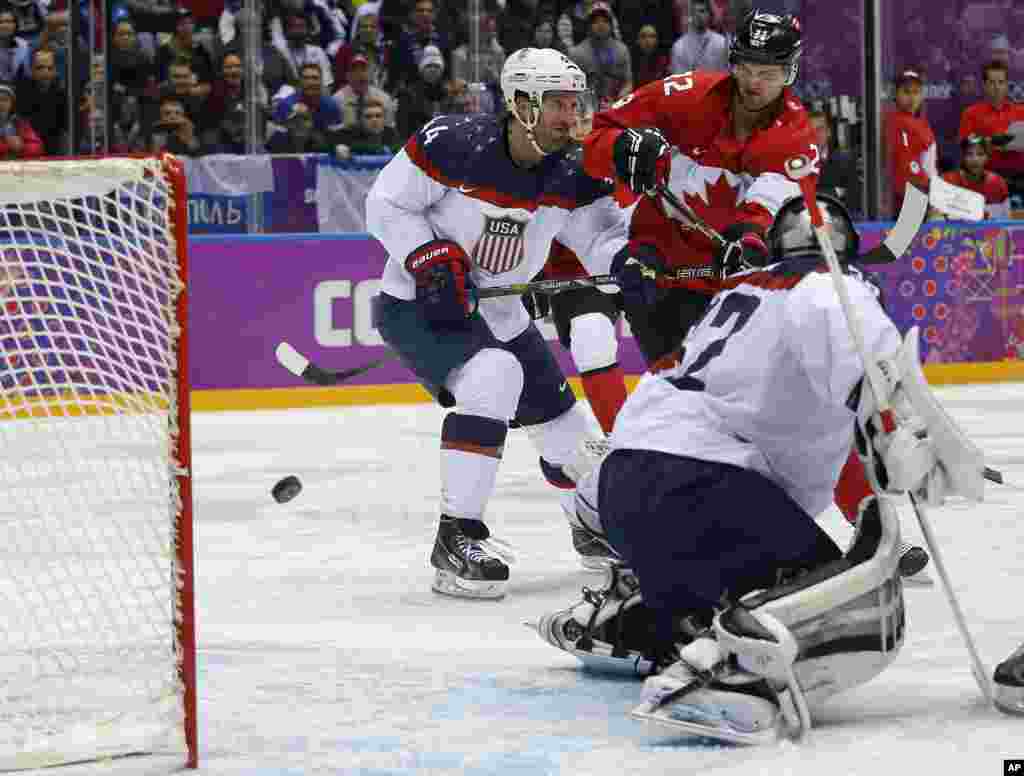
[430,516,509,599]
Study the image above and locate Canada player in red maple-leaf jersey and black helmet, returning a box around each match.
[584,10,819,369]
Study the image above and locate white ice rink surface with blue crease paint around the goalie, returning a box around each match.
[41,384,1024,776]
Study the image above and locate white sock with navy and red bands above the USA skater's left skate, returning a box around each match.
[441,413,508,519]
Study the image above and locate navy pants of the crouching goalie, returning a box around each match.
[598,450,842,647]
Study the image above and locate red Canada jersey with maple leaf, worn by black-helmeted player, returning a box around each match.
[584,71,820,293]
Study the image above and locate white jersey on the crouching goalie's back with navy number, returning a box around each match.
[611,259,900,522]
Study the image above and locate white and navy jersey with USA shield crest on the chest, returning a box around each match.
[367,116,627,342]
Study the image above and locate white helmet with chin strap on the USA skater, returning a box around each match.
[502,48,587,154]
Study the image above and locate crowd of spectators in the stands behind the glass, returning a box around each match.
[0,0,750,159]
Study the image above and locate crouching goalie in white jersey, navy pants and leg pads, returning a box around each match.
[539,197,983,744]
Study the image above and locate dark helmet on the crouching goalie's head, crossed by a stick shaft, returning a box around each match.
[767,193,860,261]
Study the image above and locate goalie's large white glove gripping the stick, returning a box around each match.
[856,327,985,507]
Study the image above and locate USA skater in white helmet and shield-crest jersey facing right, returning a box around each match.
[367,49,626,598]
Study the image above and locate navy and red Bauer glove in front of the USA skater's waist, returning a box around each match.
[406,240,476,326]
